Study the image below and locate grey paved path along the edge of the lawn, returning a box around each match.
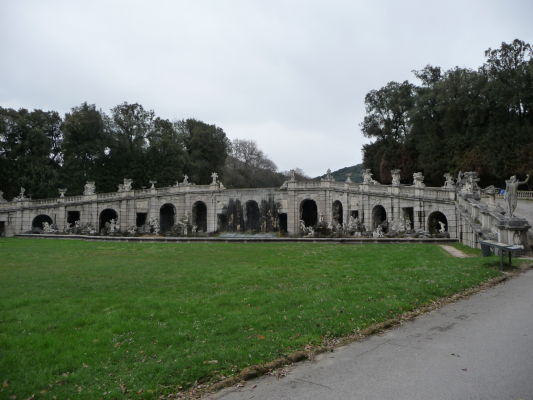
[210,270,533,400]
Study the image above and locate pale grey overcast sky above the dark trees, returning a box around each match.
[0,0,533,176]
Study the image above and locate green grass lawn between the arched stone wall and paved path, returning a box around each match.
[0,239,499,399]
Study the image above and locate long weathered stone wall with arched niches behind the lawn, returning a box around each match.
[0,176,529,247]
